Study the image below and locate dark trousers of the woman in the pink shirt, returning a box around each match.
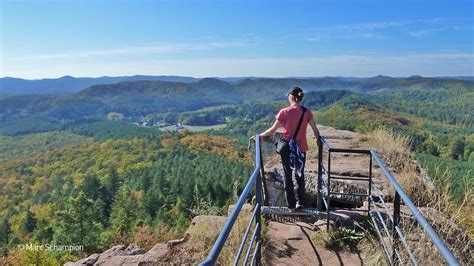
[280,148,306,208]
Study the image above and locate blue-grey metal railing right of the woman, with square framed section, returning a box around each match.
[317,136,460,265]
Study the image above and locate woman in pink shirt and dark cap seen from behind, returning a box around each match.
[260,87,319,212]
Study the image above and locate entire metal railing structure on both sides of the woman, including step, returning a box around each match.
[200,135,460,265]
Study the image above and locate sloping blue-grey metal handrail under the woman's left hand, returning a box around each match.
[200,134,264,265]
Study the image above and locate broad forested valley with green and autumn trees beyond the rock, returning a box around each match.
[0,76,474,263]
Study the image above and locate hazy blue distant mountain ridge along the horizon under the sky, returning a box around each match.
[0,75,474,96]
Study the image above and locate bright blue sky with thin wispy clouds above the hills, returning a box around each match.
[0,0,474,79]
